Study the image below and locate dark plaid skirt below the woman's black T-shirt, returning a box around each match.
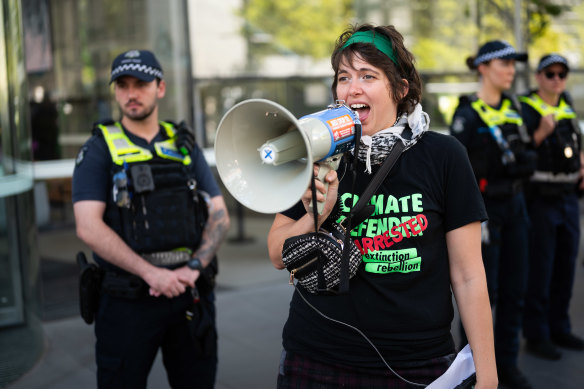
[278,350,456,389]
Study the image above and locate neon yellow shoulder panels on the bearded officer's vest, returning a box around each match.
[97,122,191,166]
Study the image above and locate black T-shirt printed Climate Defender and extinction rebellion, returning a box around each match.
[283,131,487,368]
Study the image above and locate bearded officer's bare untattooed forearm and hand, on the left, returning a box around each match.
[73,200,186,297]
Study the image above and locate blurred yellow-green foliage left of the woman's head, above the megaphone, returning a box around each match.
[242,0,354,58]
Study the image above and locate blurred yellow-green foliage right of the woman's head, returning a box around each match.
[410,0,584,70]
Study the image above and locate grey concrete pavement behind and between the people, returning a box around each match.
[4,215,584,389]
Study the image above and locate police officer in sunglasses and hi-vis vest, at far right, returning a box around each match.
[520,54,584,360]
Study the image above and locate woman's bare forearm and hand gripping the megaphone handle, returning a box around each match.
[268,164,339,269]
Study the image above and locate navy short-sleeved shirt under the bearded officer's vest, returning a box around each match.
[72,123,221,271]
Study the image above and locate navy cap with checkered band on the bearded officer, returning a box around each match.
[110,50,162,84]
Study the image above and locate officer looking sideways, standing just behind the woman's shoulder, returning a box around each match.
[450,40,535,389]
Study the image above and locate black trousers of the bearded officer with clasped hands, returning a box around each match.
[95,286,217,389]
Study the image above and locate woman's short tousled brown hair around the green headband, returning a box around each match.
[331,24,422,114]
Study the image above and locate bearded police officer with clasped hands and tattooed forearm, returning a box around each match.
[73,50,229,389]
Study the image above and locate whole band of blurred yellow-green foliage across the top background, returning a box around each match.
[240,0,584,71]
